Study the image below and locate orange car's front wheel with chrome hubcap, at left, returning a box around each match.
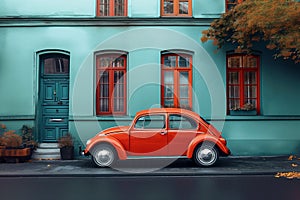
[92,144,117,167]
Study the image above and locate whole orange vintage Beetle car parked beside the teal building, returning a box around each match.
[83,108,230,167]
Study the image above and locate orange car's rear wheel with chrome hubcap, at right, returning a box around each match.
[193,143,219,167]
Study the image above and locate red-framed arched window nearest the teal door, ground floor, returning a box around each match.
[96,52,127,115]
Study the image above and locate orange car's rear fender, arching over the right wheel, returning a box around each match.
[187,136,229,158]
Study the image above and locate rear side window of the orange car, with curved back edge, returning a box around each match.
[169,114,198,130]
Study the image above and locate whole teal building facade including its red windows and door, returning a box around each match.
[0,0,300,156]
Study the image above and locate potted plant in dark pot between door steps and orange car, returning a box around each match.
[58,133,74,160]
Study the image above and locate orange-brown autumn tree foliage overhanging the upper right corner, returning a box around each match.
[201,0,300,63]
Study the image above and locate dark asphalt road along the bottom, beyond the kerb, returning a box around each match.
[0,175,300,200]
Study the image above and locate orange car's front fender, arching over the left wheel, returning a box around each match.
[86,136,127,160]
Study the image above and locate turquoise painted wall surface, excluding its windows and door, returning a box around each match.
[0,0,300,155]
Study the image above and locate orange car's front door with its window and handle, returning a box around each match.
[129,114,168,156]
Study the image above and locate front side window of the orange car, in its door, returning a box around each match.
[134,115,166,129]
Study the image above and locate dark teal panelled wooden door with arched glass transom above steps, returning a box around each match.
[39,54,69,142]
